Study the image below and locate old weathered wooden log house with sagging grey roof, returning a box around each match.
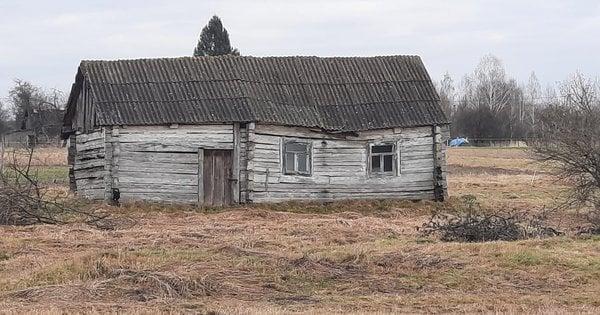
[64,56,448,205]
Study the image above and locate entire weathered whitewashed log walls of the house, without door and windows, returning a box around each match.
[72,123,447,203]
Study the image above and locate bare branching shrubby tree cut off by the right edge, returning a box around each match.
[534,73,600,231]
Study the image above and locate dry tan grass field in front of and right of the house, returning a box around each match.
[0,148,600,314]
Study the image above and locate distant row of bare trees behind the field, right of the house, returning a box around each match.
[436,55,598,139]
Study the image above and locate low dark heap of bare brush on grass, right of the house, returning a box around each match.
[420,197,562,242]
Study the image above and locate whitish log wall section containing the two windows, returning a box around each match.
[247,124,445,202]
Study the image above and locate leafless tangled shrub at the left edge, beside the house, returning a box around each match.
[0,144,108,227]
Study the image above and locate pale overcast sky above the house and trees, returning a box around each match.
[0,0,600,97]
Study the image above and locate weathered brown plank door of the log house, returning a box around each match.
[202,150,233,206]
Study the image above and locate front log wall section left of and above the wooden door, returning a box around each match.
[106,124,239,203]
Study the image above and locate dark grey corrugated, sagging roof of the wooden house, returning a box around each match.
[71,56,447,131]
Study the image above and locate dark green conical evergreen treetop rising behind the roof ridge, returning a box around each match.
[194,15,240,57]
